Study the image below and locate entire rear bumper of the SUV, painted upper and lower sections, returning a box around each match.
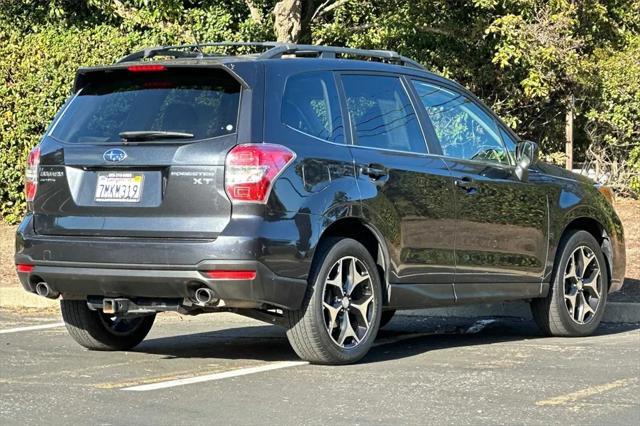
[15,216,307,309]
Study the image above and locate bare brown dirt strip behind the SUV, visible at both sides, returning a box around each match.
[0,199,640,301]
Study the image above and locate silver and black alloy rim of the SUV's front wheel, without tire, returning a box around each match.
[564,246,602,324]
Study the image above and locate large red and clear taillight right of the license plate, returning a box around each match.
[224,143,295,203]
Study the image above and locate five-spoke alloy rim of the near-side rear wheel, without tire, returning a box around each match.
[322,256,377,349]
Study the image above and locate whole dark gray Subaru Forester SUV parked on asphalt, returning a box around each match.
[15,43,625,364]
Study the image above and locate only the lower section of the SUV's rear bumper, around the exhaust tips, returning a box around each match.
[18,261,307,309]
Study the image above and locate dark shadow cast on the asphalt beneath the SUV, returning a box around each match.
[135,316,640,363]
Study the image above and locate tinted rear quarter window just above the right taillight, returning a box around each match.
[282,72,344,143]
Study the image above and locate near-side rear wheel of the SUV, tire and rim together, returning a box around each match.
[285,238,382,365]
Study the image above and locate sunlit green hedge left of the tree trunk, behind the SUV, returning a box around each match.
[0,0,260,223]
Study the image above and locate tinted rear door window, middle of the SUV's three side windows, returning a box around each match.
[342,75,427,153]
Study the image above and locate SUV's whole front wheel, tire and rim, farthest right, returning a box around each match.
[531,230,609,336]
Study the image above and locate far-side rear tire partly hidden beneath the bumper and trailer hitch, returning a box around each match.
[60,299,156,351]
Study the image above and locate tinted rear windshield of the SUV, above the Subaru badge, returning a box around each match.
[50,68,240,143]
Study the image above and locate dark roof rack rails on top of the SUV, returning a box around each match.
[118,41,425,70]
